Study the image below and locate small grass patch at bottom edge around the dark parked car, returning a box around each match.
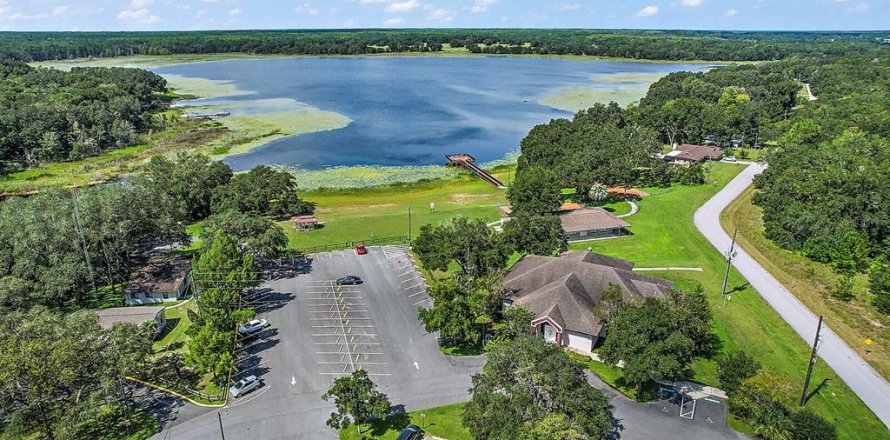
[340,403,473,440]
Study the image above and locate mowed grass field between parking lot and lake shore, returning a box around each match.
[279,166,514,249]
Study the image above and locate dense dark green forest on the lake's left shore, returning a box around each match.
[0,60,167,166]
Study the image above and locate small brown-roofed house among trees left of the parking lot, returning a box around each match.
[124,256,191,305]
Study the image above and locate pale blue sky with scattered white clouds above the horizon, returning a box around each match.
[0,0,890,31]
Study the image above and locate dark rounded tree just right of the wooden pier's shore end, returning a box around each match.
[507,166,562,214]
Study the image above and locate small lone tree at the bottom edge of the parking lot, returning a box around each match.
[321,370,390,434]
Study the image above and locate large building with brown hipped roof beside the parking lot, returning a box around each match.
[504,251,672,354]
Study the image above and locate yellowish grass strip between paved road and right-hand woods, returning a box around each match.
[720,187,890,377]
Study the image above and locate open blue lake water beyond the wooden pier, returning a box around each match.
[153,57,705,170]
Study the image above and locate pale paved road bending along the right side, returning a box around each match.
[695,164,890,427]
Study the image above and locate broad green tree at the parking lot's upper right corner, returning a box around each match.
[414,217,511,277]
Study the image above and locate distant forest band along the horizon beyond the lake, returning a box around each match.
[0,29,885,61]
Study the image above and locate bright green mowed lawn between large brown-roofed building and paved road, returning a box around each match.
[571,164,890,440]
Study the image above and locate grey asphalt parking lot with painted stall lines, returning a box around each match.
[155,246,484,440]
